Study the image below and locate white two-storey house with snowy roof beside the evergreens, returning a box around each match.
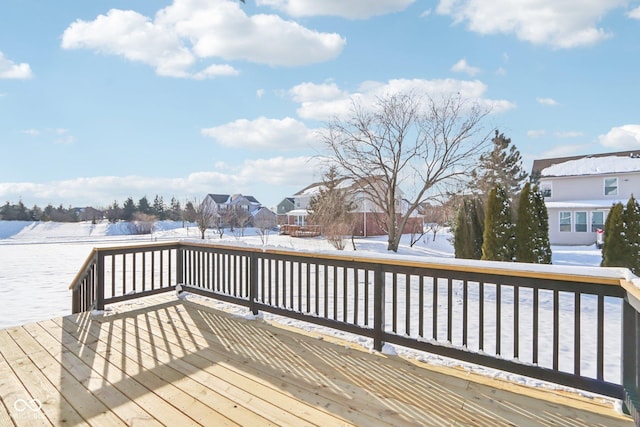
[531,151,640,245]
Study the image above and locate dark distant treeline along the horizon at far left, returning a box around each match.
[0,195,196,222]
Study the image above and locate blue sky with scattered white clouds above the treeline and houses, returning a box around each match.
[0,0,640,211]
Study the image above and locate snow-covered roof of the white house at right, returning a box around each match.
[531,151,640,177]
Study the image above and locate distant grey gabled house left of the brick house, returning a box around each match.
[202,194,277,228]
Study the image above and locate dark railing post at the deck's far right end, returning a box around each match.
[622,294,640,426]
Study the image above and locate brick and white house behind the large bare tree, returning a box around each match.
[281,179,423,236]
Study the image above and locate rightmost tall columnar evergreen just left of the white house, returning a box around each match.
[515,183,551,264]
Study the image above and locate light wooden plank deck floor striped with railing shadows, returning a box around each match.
[0,294,633,427]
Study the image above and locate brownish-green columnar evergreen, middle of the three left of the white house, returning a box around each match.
[482,186,514,261]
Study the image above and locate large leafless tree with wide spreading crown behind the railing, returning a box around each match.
[322,92,493,252]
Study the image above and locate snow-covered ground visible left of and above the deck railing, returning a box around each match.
[0,221,619,404]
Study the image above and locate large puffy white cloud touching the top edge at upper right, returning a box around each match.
[436,0,626,48]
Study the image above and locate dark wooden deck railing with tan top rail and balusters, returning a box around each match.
[71,243,640,425]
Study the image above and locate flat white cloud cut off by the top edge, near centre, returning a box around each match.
[256,0,415,19]
